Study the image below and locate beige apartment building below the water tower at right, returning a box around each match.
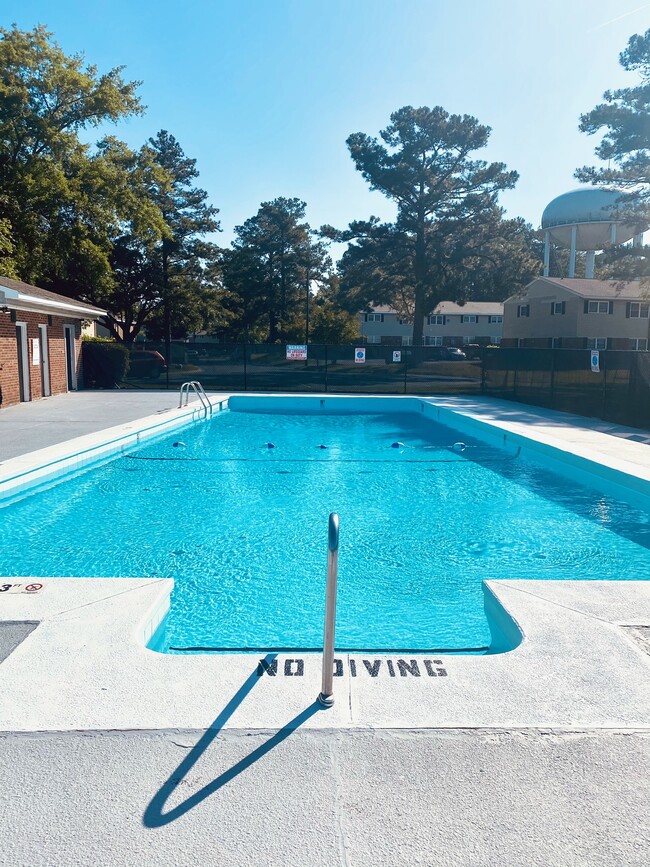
[502,277,650,351]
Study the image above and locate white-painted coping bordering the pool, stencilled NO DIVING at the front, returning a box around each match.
[0,394,650,731]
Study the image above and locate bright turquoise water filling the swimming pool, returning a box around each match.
[0,412,650,652]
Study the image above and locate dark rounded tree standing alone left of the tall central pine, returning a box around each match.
[224,197,330,343]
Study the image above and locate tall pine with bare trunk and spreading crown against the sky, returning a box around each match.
[347,106,518,345]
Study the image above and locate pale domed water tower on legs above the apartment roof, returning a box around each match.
[542,187,647,277]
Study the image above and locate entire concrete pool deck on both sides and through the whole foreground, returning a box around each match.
[0,392,650,867]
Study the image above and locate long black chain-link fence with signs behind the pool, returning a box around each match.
[119,341,650,427]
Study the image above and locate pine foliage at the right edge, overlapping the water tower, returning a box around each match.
[576,30,650,277]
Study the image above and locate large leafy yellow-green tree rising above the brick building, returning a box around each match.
[0,26,142,284]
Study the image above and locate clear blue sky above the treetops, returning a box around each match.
[5,0,650,254]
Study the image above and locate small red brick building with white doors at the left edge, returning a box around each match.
[0,276,105,406]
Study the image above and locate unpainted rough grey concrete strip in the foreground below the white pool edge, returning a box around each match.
[0,731,650,867]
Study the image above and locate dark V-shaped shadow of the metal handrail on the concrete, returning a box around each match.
[142,654,322,828]
